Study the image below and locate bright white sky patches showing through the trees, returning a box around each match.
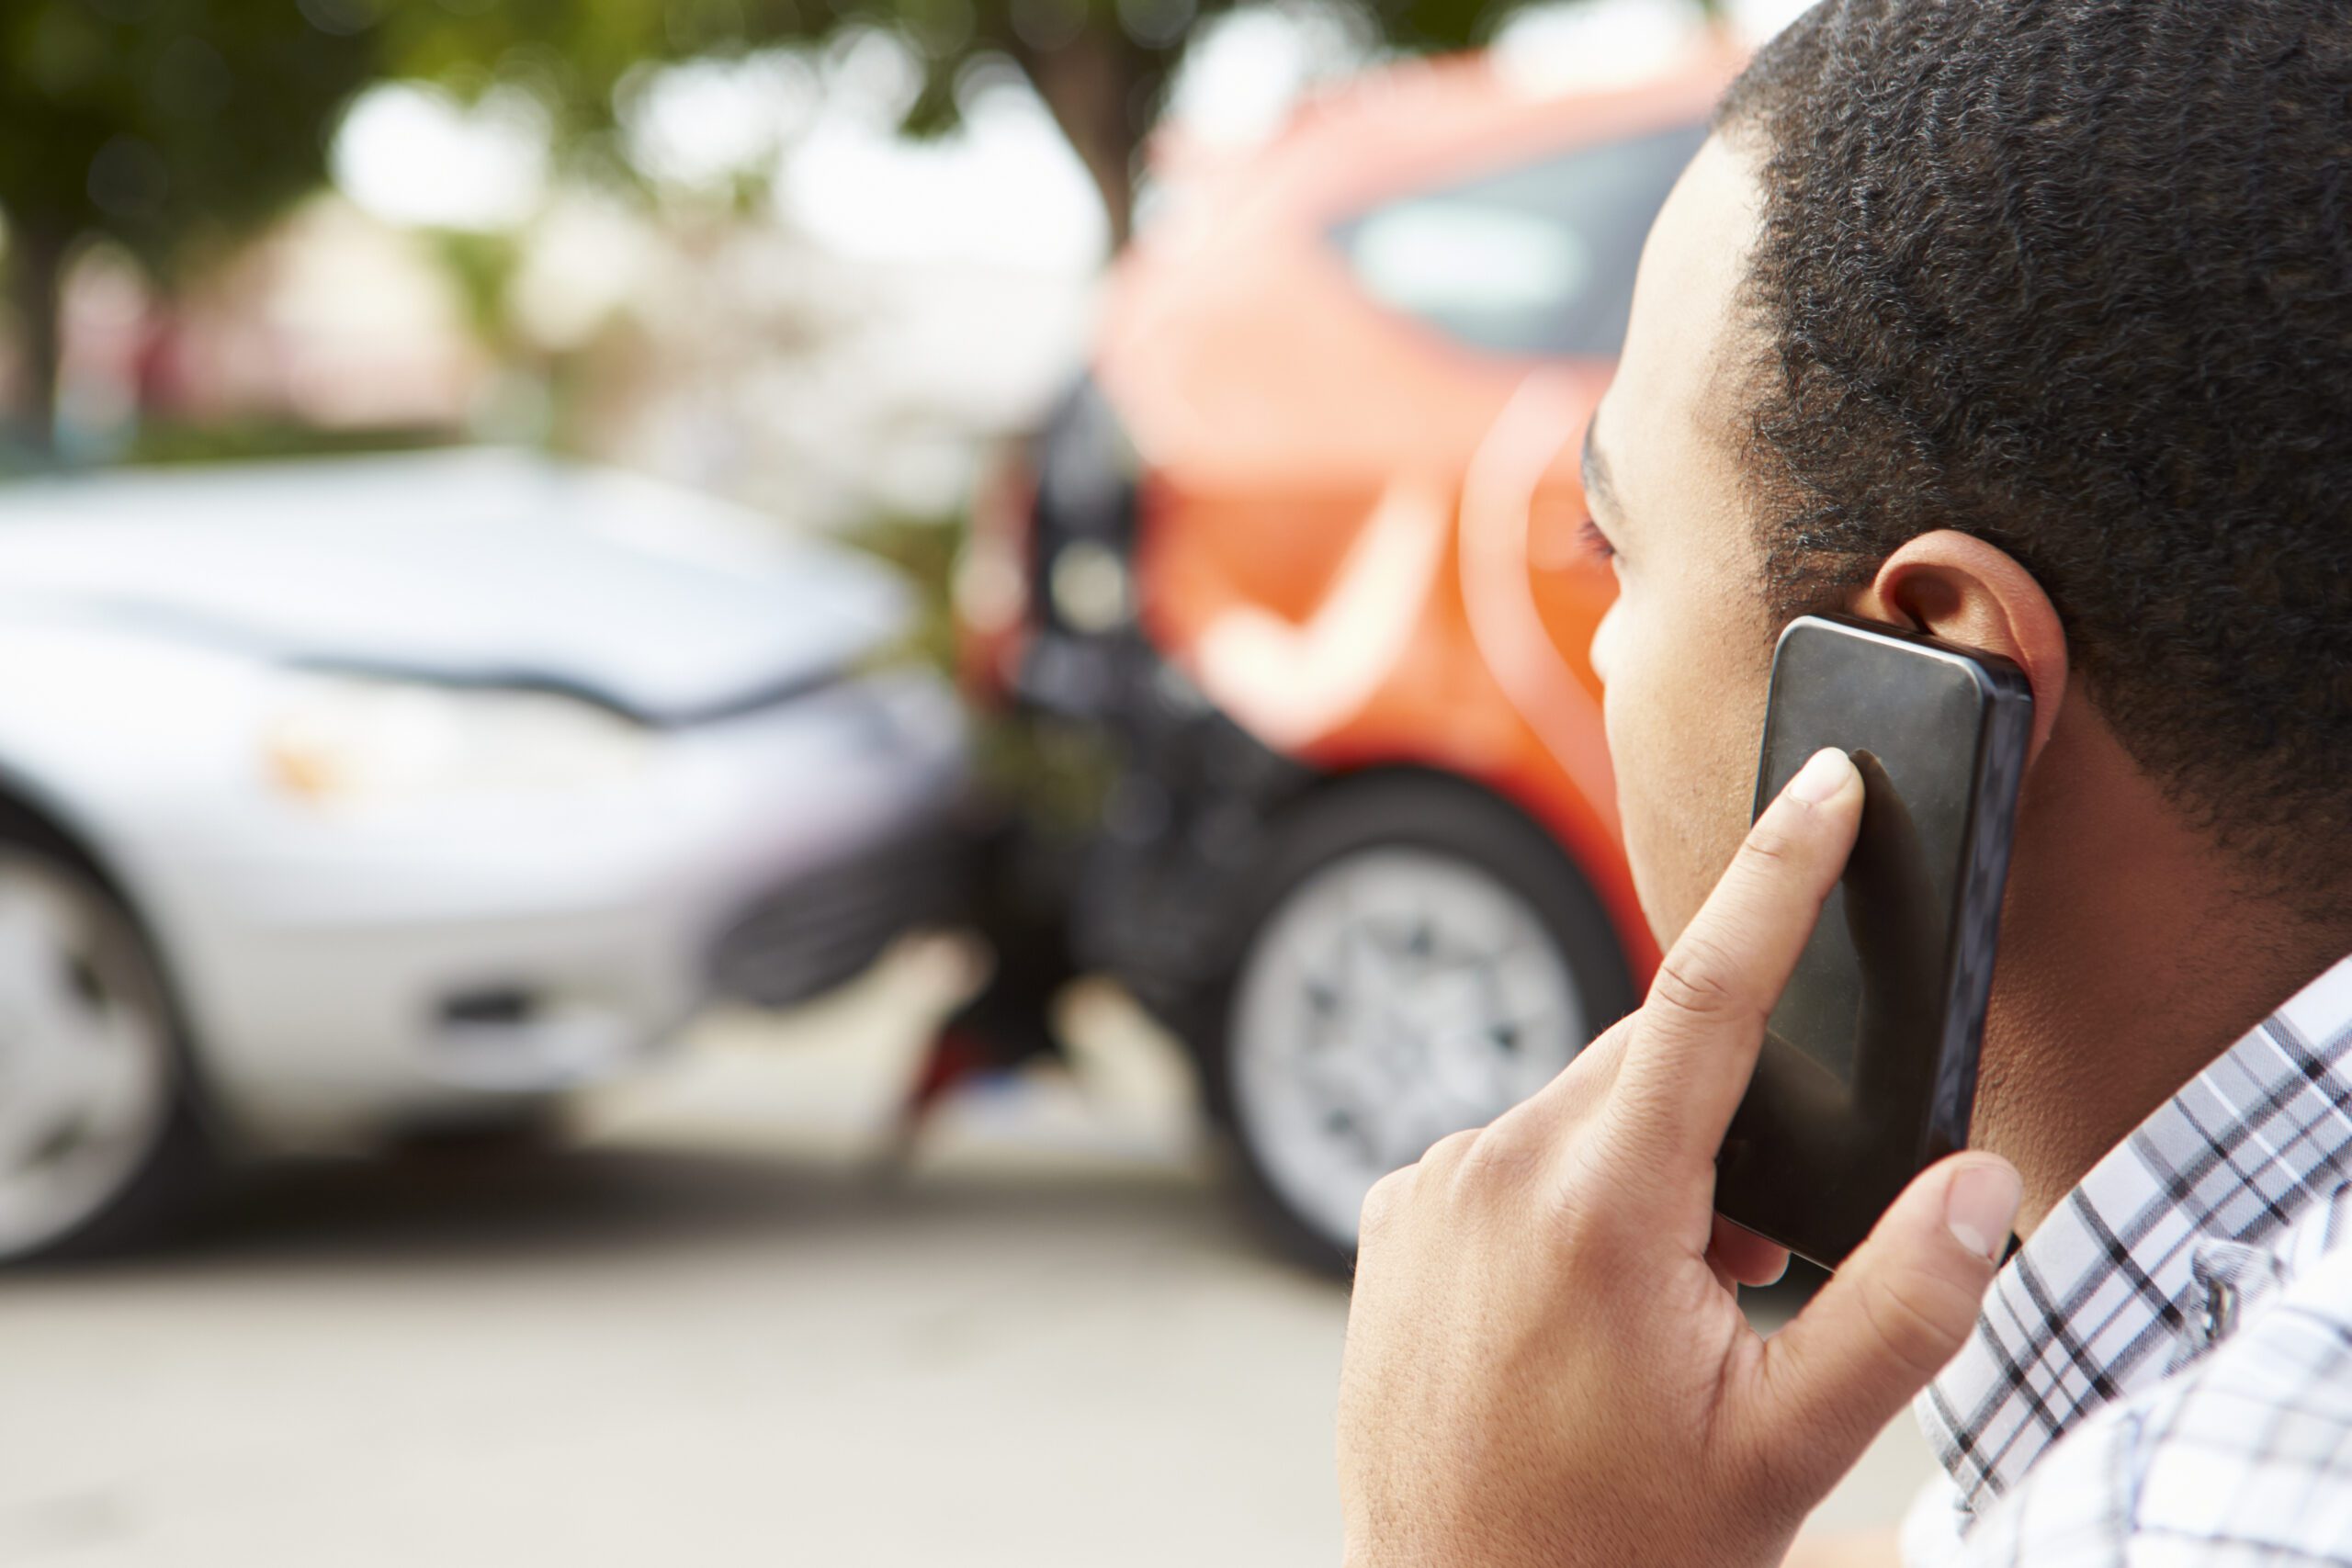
[334,0,1804,275]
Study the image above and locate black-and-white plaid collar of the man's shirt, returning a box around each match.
[1915,959,2352,1512]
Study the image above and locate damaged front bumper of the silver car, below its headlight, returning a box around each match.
[126,674,969,1140]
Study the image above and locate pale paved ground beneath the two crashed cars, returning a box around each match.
[0,952,1927,1568]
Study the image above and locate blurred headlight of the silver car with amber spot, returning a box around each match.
[264,674,650,804]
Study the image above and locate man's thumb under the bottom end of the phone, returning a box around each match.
[1755,1155,2020,1493]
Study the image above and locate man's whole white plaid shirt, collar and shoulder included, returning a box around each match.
[1905,959,2352,1568]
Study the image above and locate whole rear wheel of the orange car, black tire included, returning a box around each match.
[1200,773,1634,1269]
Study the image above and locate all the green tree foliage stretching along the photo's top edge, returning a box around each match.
[0,0,1713,445]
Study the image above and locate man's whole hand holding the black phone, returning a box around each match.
[1339,752,2018,1568]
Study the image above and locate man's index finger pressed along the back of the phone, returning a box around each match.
[1618,748,1863,1156]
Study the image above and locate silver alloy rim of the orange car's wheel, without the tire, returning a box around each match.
[1230,846,1590,1248]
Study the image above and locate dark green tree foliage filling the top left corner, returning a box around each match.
[0,0,380,446]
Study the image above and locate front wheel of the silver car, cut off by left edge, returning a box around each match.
[0,840,207,1265]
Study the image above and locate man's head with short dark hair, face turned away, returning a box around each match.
[1588,0,2352,936]
